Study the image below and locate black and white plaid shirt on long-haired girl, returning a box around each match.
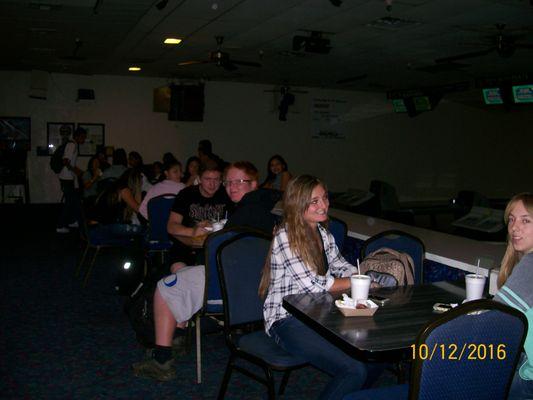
[263,224,357,334]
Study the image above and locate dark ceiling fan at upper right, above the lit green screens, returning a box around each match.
[435,24,533,64]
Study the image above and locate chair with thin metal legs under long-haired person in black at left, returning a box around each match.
[75,207,136,286]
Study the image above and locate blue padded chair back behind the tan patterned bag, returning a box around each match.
[361,230,426,285]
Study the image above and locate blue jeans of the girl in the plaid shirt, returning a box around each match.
[270,317,367,400]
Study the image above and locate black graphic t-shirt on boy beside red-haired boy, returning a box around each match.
[172,185,233,228]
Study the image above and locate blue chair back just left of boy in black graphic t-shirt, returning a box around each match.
[145,193,176,264]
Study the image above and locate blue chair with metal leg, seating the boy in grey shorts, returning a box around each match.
[195,227,242,383]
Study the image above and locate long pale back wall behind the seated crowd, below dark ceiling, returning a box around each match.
[0,71,533,203]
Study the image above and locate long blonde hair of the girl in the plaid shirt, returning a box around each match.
[259,175,327,297]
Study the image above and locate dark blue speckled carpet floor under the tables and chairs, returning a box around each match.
[0,206,391,399]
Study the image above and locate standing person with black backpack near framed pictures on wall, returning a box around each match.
[56,128,87,233]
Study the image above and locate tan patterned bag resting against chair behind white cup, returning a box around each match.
[360,247,414,287]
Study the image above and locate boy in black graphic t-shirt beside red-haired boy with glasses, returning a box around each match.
[167,162,233,265]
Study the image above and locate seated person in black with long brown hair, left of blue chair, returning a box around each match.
[87,169,145,240]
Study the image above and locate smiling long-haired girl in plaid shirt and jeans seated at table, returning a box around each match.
[259,175,374,399]
